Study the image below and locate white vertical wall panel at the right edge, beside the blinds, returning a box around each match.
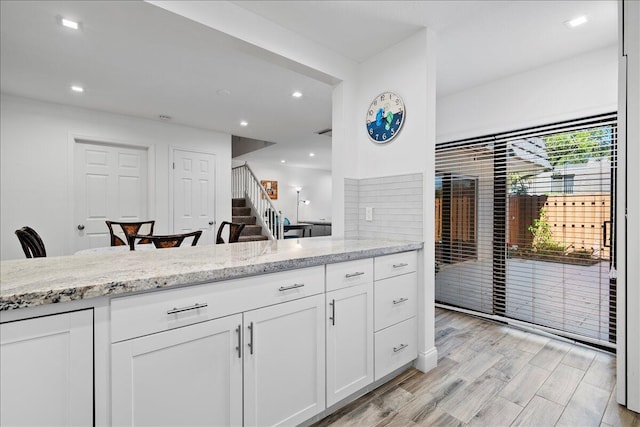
[617,0,640,412]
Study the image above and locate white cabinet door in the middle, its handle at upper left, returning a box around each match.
[244,295,325,427]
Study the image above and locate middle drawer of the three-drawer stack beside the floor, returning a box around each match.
[374,273,418,331]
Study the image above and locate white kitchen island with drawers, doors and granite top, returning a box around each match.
[0,237,422,426]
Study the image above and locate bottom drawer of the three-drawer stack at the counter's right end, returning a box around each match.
[375,317,418,381]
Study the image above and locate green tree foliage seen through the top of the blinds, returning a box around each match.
[543,126,612,168]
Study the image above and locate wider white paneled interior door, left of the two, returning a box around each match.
[74,141,150,251]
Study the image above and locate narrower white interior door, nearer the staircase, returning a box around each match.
[173,149,216,244]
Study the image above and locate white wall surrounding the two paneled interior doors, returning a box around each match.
[0,94,231,259]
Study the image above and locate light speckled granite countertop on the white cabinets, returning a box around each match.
[0,237,423,311]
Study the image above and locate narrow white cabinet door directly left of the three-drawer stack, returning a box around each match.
[326,283,373,406]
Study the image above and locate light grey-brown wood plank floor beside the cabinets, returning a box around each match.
[314,309,640,427]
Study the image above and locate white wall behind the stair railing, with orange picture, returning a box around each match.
[234,161,332,223]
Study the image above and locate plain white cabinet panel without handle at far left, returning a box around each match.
[0,310,93,426]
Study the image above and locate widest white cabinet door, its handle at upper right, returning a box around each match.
[112,314,242,426]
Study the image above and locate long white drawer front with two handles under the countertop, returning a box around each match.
[111,266,324,342]
